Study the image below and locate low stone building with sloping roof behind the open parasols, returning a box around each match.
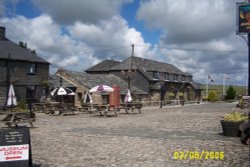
[53,69,147,106]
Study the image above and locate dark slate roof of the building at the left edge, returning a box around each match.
[0,39,50,64]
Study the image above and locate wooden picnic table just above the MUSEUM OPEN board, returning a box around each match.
[0,111,35,127]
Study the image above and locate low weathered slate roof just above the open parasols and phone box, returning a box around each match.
[56,70,147,94]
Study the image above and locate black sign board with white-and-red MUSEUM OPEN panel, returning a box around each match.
[0,127,32,167]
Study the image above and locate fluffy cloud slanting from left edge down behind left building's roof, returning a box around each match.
[0,15,95,71]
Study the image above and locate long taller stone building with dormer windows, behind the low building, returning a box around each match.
[86,56,201,102]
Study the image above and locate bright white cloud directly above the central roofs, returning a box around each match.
[69,16,150,59]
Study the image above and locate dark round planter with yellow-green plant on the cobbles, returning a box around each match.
[221,111,248,137]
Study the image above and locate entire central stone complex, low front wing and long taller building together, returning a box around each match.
[56,57,201,104]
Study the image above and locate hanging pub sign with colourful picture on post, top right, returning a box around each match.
[237,3,250,34]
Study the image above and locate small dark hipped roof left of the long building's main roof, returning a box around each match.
[86,60,120,72]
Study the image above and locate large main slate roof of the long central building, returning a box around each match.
[111,57,191,76]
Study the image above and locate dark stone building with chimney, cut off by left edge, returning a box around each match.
[0,27,50,106]
